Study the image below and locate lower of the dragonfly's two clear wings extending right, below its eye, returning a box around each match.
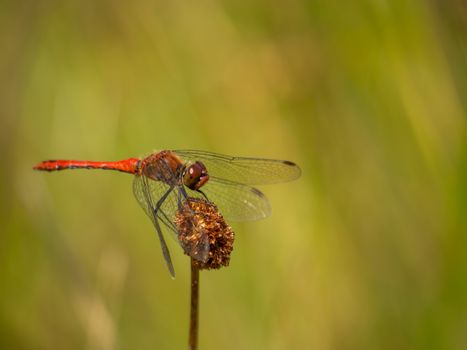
[183,178,271,221]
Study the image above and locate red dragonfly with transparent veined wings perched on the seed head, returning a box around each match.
[34,150,301,277]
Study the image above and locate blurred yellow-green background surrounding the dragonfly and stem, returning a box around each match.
[0,0,467,350]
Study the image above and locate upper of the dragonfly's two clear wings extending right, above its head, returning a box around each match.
[173,150,301,185]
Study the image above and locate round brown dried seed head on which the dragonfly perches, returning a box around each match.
[175,198,235,269]
